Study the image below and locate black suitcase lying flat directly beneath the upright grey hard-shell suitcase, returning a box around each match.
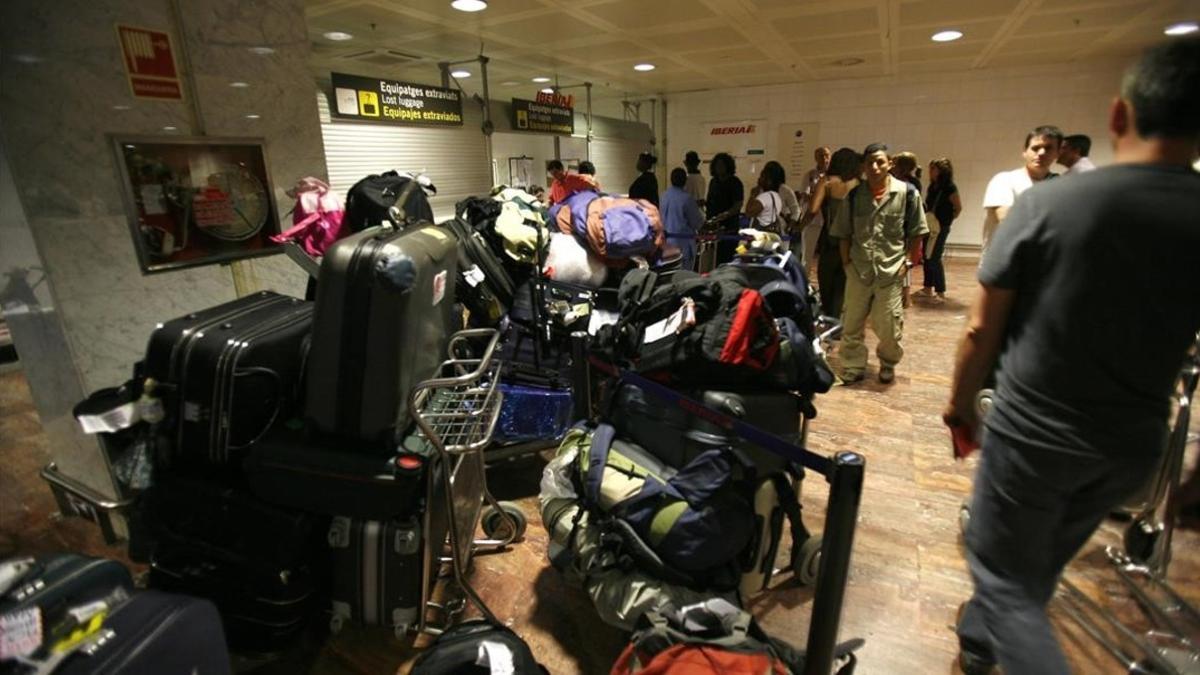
[245,430,431,520]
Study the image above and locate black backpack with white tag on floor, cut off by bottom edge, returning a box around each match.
[410,619,548,675]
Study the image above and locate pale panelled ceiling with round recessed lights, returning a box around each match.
[305,0,1200,107]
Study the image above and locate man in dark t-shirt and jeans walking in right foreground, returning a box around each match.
[943,38,1200,675]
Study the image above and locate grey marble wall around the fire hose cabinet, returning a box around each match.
[0,0,326,390]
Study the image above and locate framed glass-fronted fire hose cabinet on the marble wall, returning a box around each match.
[113,137,282,274]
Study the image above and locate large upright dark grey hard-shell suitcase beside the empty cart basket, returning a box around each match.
[305,225,462,450]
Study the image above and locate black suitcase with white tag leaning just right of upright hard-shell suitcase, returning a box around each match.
[442,219,514,327]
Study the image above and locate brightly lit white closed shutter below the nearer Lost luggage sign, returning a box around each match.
[317,91,492,220]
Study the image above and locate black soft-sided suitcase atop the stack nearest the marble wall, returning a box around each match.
[138,291,312,465]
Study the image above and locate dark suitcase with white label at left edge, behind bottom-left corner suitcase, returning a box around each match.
[0,554,133,659]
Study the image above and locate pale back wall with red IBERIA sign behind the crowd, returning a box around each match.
[667,61,1124,245]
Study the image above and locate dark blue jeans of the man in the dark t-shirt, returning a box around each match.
[958,432,1159,675]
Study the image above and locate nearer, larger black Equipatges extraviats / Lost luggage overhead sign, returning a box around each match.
[330,72,462,126]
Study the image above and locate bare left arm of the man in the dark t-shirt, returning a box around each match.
[942,283,1016,436]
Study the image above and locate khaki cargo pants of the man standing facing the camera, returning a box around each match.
[838,267,904,378]
